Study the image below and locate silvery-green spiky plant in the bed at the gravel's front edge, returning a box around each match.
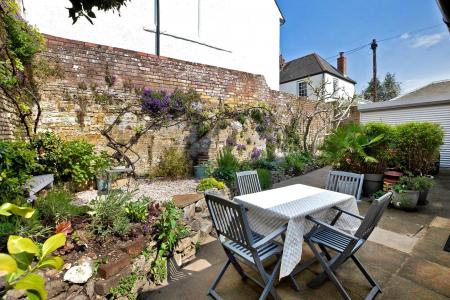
[89,191,133,238]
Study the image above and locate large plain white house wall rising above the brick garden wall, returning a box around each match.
[23,0,281,90]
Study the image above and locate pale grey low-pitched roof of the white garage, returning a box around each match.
[358,79,450,111]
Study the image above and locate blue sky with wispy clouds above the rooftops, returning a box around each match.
[277,0,450,93]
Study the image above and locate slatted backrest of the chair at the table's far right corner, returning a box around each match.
[325,171,364,200]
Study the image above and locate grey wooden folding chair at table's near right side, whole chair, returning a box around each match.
[305,192,392,299]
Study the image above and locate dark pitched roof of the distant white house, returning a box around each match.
[280,53,356,84]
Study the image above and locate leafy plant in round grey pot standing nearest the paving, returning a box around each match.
[392,176,420,211]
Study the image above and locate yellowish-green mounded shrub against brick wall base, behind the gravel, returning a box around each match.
[153,147,191,178]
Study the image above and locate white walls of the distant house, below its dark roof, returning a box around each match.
[280,73,355,99]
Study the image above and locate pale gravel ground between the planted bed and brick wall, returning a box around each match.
[74,179,198,205]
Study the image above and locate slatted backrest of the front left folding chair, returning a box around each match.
[205,193,253,249]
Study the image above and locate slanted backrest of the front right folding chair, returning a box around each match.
[355,192,392,240]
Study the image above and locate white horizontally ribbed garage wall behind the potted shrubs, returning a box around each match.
[360,104,450,168]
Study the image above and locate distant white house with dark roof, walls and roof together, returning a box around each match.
[280,53,356,100]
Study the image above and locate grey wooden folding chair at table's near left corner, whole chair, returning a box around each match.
[205,193,299,299]
